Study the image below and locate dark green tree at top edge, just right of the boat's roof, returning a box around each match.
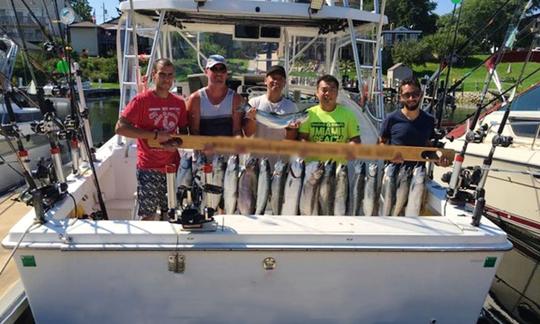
[384,0,438,35]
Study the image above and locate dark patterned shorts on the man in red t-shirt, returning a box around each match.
[137,169,167,217]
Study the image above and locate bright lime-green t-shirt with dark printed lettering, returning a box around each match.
[298,105,360,161]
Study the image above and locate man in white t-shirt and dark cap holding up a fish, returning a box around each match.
[244,65,298,140]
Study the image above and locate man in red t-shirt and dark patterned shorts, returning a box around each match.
[116,59,188,220]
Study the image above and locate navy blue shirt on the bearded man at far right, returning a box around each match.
[380,109,435,146]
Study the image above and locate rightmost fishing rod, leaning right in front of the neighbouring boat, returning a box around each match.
[471,24,539,226]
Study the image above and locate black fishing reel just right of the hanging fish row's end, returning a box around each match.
[441,166,482,204]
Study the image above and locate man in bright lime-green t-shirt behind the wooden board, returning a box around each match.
[298,74,360,143]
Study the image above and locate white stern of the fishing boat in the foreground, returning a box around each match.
[4,216,510,323]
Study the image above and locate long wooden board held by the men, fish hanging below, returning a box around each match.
[148,135,455,162]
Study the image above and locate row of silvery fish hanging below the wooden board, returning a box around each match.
[177,153,425,216]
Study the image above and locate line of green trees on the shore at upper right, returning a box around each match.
[386,0,540,65]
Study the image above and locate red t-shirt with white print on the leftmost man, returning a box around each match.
[122,90,188,172]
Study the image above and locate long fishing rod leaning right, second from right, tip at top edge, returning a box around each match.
[446,0,532,199]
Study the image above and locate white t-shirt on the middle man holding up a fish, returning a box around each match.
[249,94,298,140]
